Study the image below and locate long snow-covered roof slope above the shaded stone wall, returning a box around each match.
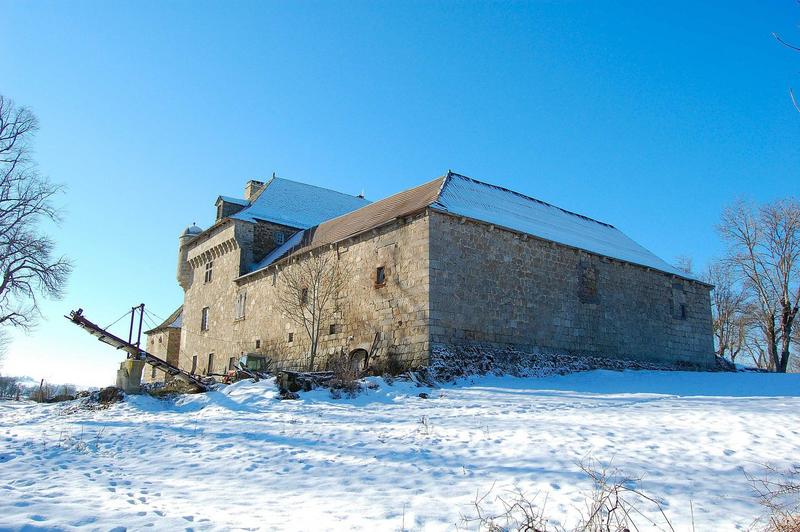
[432,173,691,278]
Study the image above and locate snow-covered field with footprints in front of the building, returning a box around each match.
[0,371,800,531]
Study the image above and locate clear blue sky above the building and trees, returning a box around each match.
[0,0,800,385]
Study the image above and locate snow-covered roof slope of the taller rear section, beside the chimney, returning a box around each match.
[231,177,370,229]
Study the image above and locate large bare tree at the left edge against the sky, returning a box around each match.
[0,95,71,328]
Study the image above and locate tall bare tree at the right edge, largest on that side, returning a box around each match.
[719,199,800,373]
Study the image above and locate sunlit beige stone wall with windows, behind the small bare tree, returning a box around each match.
[180,215,429,374]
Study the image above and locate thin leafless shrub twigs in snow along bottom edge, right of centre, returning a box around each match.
[462,463,674,532]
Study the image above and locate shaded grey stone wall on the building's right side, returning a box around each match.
[429,212,714,366]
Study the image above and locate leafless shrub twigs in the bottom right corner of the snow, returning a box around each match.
[747,466,800,532]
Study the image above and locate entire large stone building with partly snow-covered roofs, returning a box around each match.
[148,172,714,375]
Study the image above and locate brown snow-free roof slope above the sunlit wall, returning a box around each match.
[290,176,445,255]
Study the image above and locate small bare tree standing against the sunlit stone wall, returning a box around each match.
[277,252,347,371]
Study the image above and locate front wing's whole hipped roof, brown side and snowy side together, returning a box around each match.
[236,172,694,279]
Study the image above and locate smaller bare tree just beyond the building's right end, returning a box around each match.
[703,261,752,362]
